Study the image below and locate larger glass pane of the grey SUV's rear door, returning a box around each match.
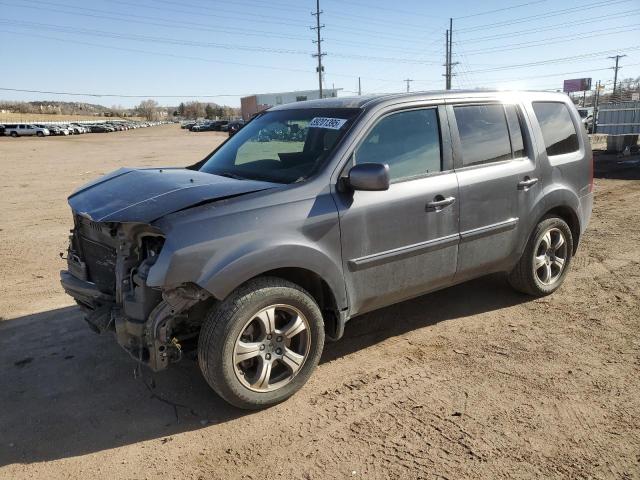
[453,104,512,167]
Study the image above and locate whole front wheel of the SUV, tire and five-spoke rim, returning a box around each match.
[198,277,324,409]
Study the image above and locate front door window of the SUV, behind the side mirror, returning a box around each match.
[354,108,442,182]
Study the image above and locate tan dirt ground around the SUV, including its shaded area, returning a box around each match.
[0,126,640,480]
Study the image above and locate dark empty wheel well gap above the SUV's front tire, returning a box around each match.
[250,267,340,338]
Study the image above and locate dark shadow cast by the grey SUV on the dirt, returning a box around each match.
[0,276,528,466]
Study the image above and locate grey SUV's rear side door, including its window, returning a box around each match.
[447,102,541,281]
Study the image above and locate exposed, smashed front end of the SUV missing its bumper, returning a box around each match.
[60,214,215,371]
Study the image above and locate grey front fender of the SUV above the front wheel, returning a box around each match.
[147,185,347,308]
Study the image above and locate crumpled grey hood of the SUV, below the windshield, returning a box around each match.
[69,168,278,223]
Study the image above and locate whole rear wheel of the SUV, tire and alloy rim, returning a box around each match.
[508,217,573,296]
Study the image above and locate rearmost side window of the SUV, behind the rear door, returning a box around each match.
[533,102,580,156]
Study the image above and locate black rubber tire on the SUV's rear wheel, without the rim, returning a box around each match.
[507,216,573,297]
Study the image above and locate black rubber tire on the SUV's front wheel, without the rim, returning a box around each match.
[198,277,324,410]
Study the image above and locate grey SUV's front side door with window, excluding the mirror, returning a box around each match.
[336,107,459,315]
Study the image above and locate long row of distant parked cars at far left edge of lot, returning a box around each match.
[0,120,168,137]
